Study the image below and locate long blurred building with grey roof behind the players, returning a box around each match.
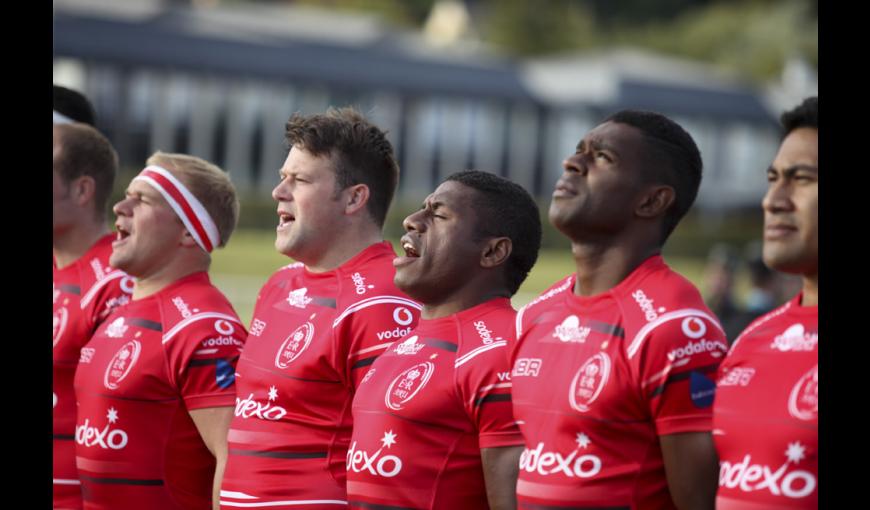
[53,0,778,210]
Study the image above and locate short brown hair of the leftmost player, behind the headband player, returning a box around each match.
[54,123,118,219]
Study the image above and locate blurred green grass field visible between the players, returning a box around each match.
[211,230,704,325]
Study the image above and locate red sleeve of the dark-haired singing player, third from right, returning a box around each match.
[456,340,523,448]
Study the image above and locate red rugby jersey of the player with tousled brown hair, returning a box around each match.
[221,242,420,509]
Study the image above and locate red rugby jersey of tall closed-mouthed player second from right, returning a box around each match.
[511,255,728,510]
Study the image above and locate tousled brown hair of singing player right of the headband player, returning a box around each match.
[286,107,399,227]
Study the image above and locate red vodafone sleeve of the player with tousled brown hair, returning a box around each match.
[333,296,420,389]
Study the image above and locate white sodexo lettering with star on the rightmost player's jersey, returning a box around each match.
[719,441,816,499]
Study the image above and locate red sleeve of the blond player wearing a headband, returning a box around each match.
[163,314,247,409]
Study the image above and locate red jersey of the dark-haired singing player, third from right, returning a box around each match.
[345,298,523,510]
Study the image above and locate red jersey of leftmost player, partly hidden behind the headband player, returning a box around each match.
[52,235,133,508]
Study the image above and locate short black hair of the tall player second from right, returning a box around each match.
[605,110,704,244]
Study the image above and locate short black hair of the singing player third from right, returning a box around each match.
[444,170,541,296]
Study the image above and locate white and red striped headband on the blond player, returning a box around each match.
[133,165,220,253]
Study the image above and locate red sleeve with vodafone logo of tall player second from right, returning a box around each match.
[628,312,728,435]
